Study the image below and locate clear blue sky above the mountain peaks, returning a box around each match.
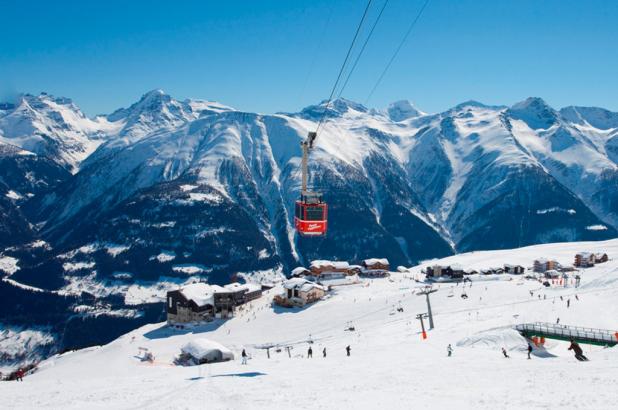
[0,0,618,115]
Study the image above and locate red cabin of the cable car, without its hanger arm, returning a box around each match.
[294,192,328,236]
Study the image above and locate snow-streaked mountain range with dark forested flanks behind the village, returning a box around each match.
[0,90,618,366]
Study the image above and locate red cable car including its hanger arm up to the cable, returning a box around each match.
[294,132,328,236]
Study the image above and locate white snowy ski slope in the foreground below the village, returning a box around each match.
[0,240,618,409]
